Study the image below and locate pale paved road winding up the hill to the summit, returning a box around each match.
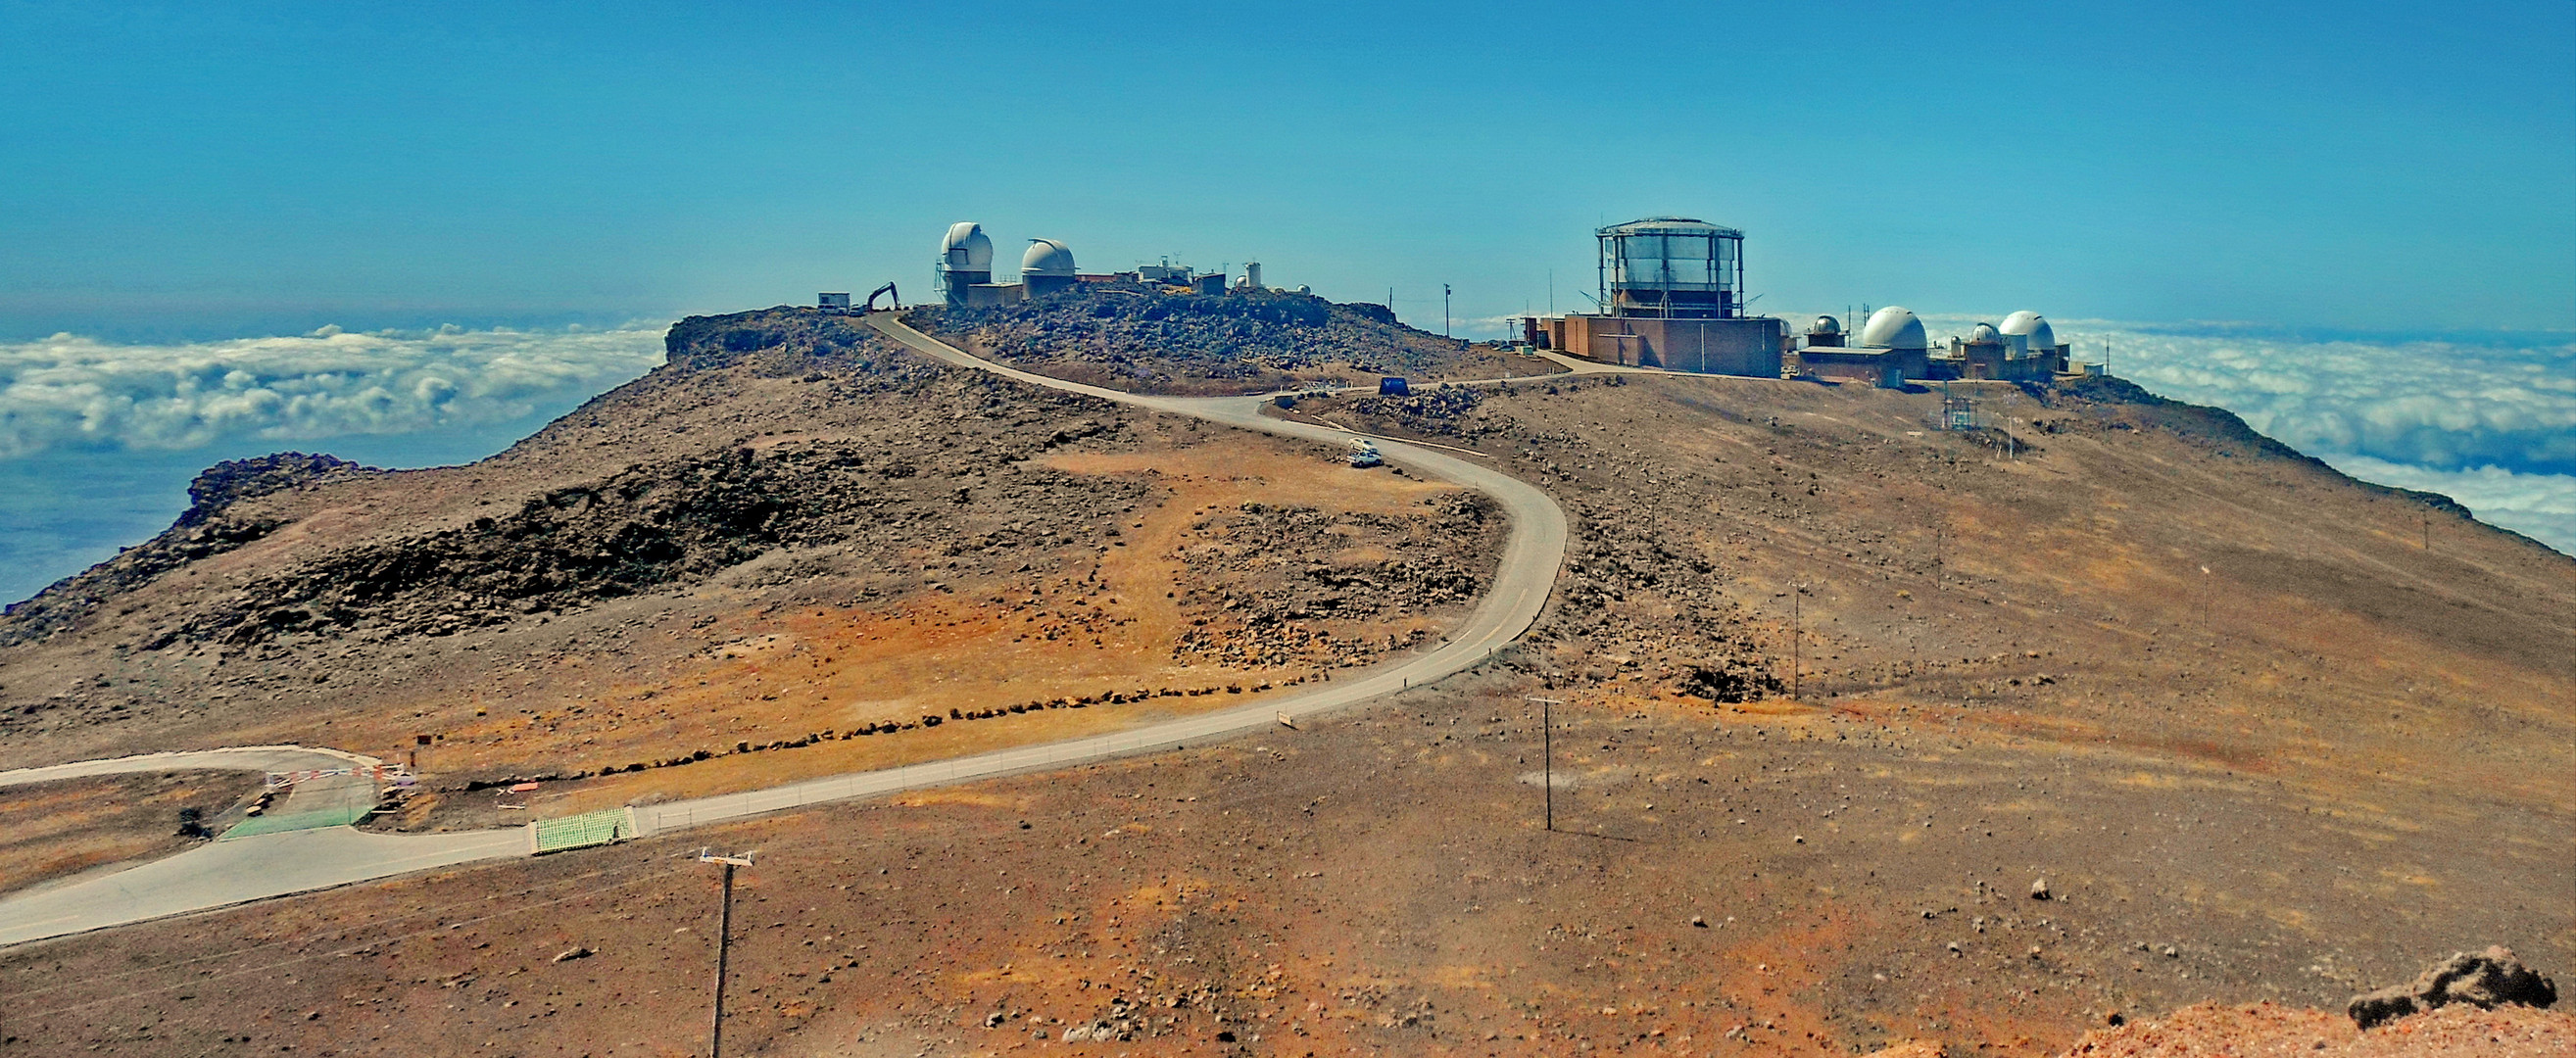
[0,314,1566,944]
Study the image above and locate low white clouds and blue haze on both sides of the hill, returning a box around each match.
[0,314,2576,602]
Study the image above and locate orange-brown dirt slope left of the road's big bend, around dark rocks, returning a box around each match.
[0,334,1499,829]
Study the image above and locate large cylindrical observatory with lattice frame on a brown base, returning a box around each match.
[1528,216,1782,378]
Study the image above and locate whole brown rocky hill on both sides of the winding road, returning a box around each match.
[0,294,2576,1055]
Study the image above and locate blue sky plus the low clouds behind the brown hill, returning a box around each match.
[0,0,2576,598]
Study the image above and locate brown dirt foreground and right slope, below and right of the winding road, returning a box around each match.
[0,365,2576,1055]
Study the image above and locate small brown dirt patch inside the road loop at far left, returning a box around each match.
[0,772,261,893]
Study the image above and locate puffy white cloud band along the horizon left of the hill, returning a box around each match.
[0,324,662,458]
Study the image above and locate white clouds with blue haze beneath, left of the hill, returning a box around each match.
[0,324,662,602]
